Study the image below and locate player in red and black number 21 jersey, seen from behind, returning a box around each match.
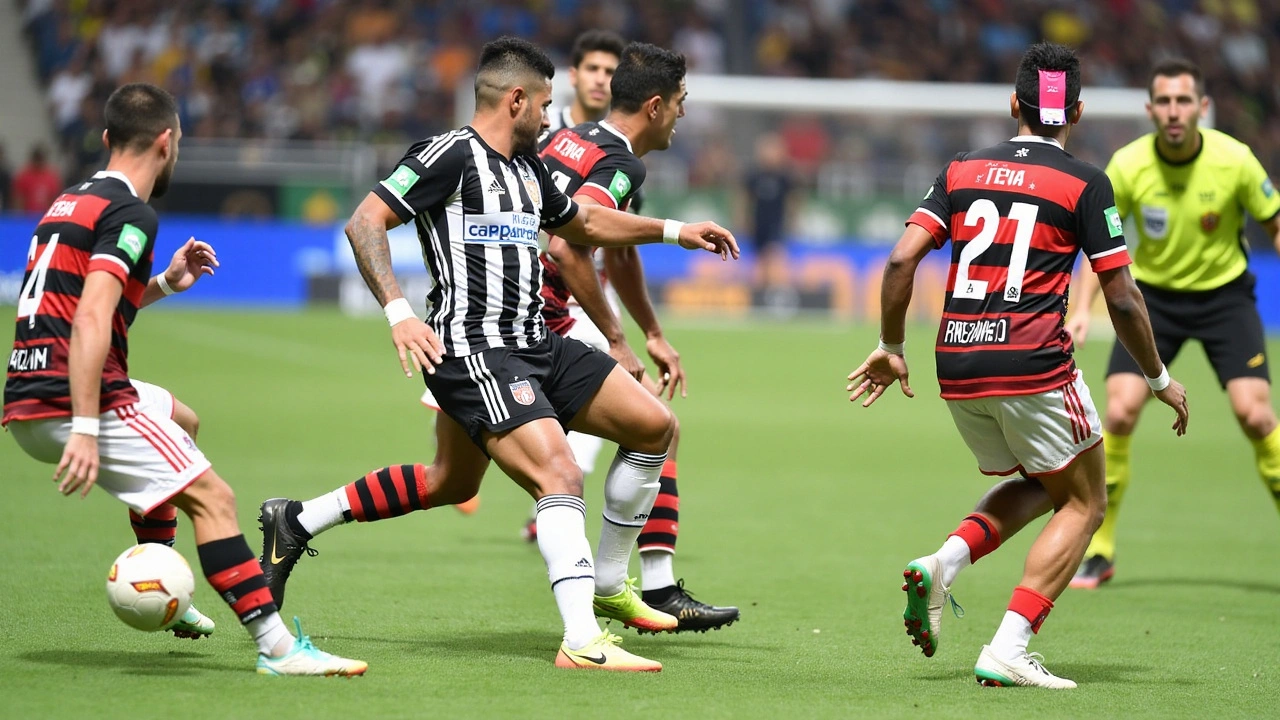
[849,44,1187,688]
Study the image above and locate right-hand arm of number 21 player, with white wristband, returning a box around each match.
[1098,265,1188,434]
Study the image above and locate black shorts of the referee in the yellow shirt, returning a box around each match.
[1107,272,1271,388]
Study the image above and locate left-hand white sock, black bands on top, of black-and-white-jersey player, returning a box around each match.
[538,495,600,650]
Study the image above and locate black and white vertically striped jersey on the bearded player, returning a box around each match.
[374,127,577,357]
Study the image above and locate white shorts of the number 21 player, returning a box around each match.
[947,372,1102,477]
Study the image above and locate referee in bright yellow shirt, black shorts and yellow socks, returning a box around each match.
[1066,59,1280,588]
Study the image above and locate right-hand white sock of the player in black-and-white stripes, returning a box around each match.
[593,447,667,597]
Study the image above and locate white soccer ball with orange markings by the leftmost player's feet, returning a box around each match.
[106,543,196,633]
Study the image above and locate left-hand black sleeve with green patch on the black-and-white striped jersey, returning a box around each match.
[374,132,467,223]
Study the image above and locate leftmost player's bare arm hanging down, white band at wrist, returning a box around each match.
[54,270,124,497]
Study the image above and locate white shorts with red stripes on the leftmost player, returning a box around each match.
[9,380,210,515]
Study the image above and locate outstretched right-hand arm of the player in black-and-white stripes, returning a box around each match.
[556,205,739,260]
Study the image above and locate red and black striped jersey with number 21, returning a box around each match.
[908,136,1130,400]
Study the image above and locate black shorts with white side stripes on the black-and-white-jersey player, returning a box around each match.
[425,332,617,450]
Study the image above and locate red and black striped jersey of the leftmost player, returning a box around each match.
[0,172,159,424]
